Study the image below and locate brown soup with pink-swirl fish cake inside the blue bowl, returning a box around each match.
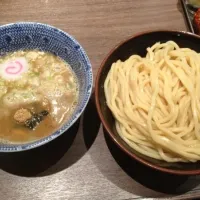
[0,50,79,144]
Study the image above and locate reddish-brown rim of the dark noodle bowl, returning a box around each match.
[95,29,200,175]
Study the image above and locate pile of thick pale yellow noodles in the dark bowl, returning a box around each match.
[104,41,200,162]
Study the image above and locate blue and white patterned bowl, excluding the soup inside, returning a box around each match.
[0,22,93,152]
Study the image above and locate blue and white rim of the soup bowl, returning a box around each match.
[0,21,94,153]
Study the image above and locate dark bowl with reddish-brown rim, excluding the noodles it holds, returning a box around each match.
[95,30,200,175]
